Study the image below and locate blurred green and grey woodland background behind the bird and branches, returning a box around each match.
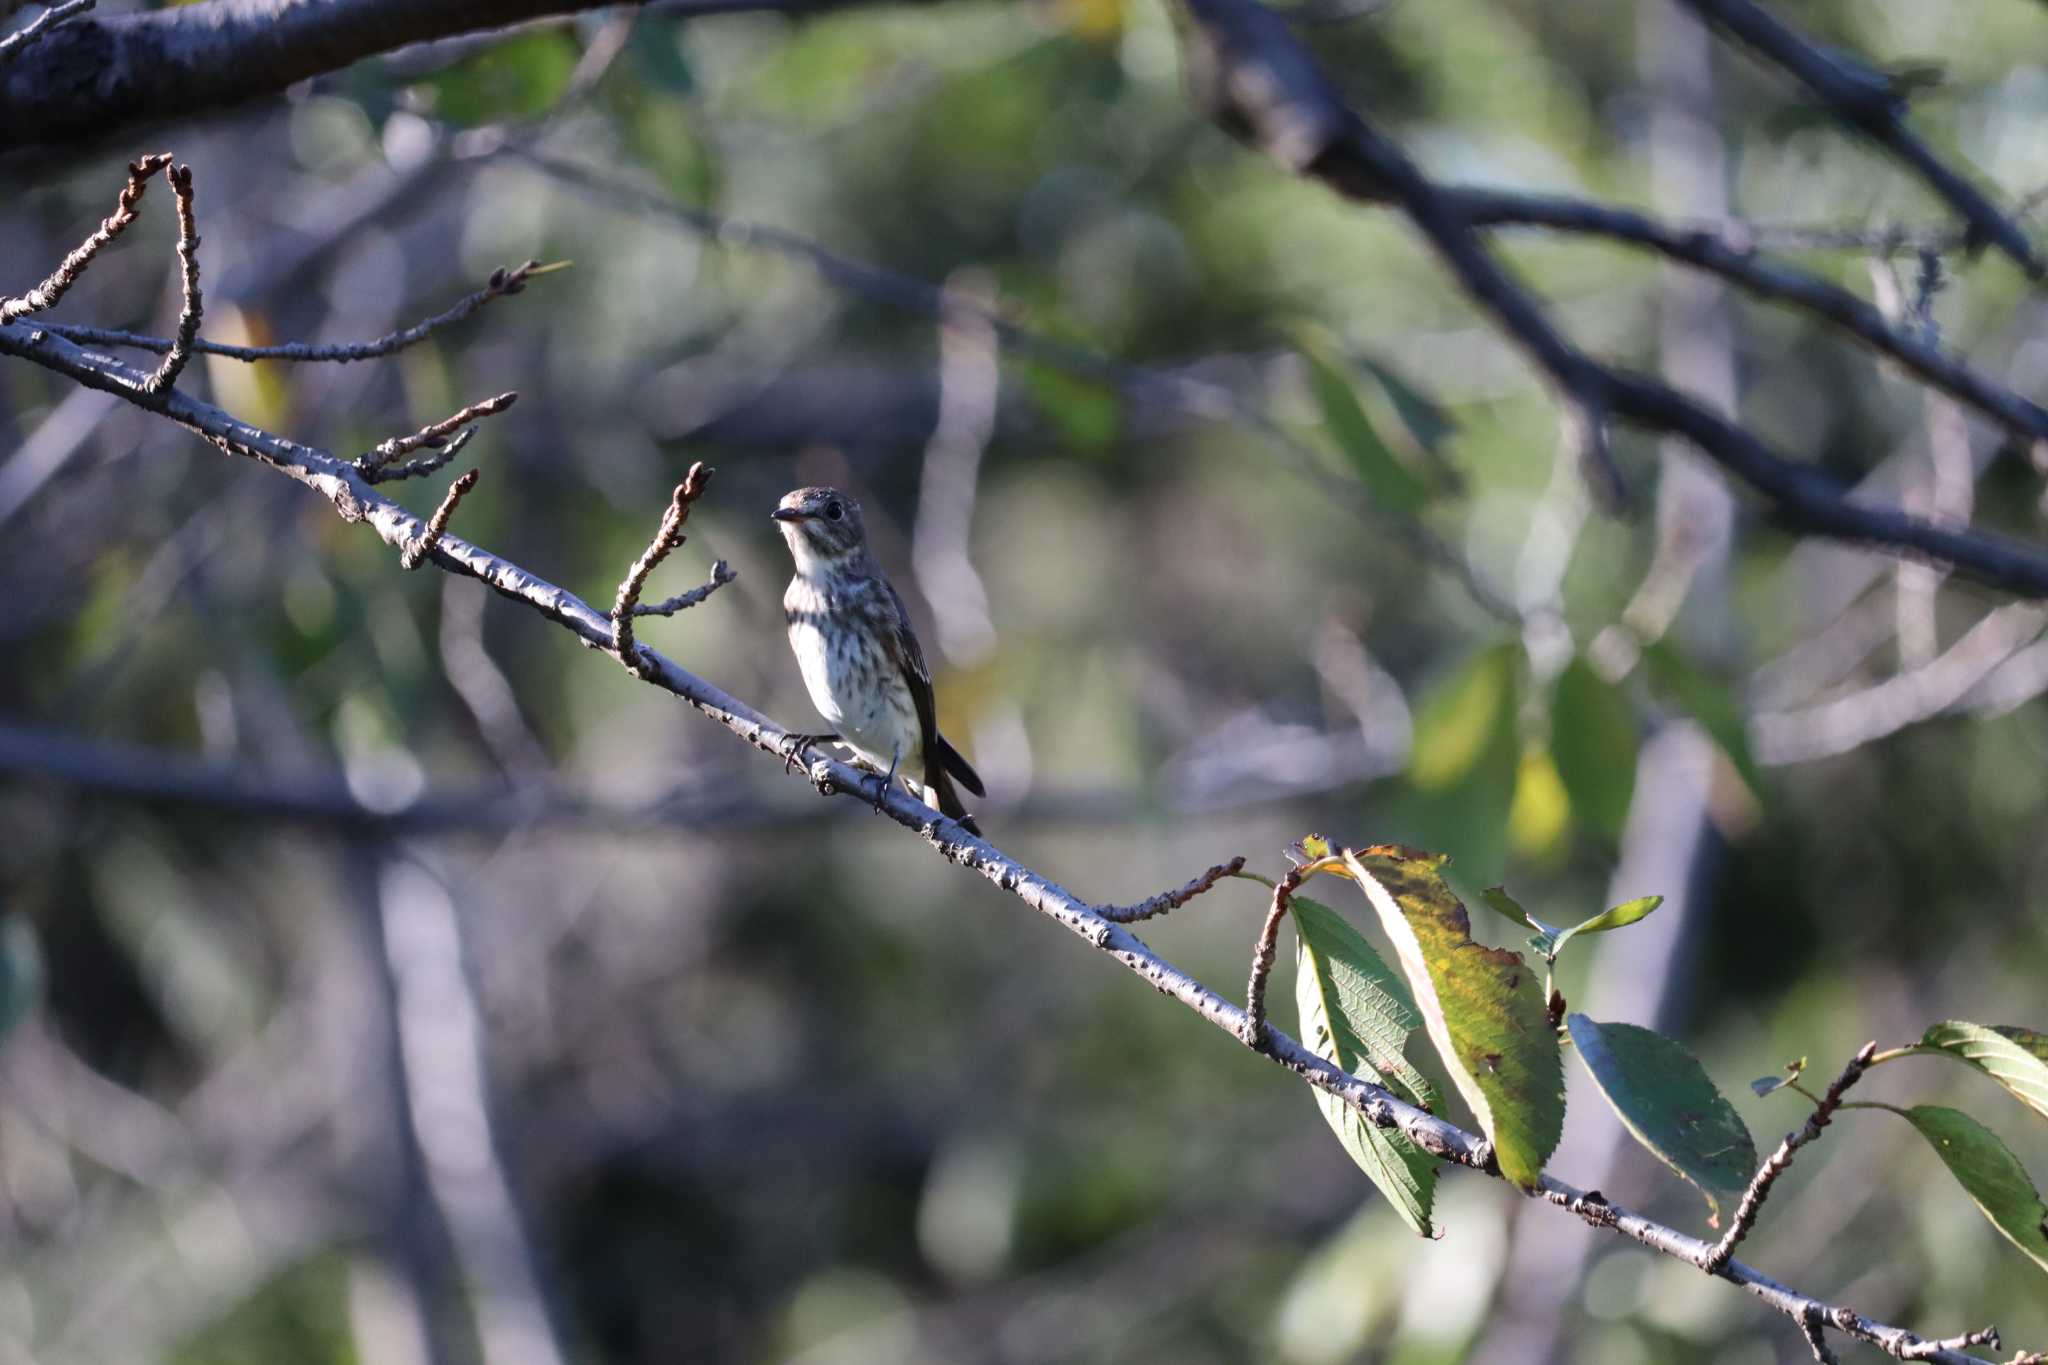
[0,0,2048,1365]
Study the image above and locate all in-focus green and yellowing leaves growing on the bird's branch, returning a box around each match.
[1292,835,2048,1271]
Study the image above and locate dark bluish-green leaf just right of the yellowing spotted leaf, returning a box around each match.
[1565,1015,1757,1228]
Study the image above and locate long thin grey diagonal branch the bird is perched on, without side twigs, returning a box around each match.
[0,327,2015,1365]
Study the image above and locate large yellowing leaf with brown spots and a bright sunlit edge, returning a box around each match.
[1346,849,1565,1189]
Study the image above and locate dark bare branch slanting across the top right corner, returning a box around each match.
[1686,0,2048,278]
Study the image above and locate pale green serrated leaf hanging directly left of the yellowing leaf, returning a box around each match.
[1292,896,1436,1236]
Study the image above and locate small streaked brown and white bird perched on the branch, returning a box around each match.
[772,487,987,835]
